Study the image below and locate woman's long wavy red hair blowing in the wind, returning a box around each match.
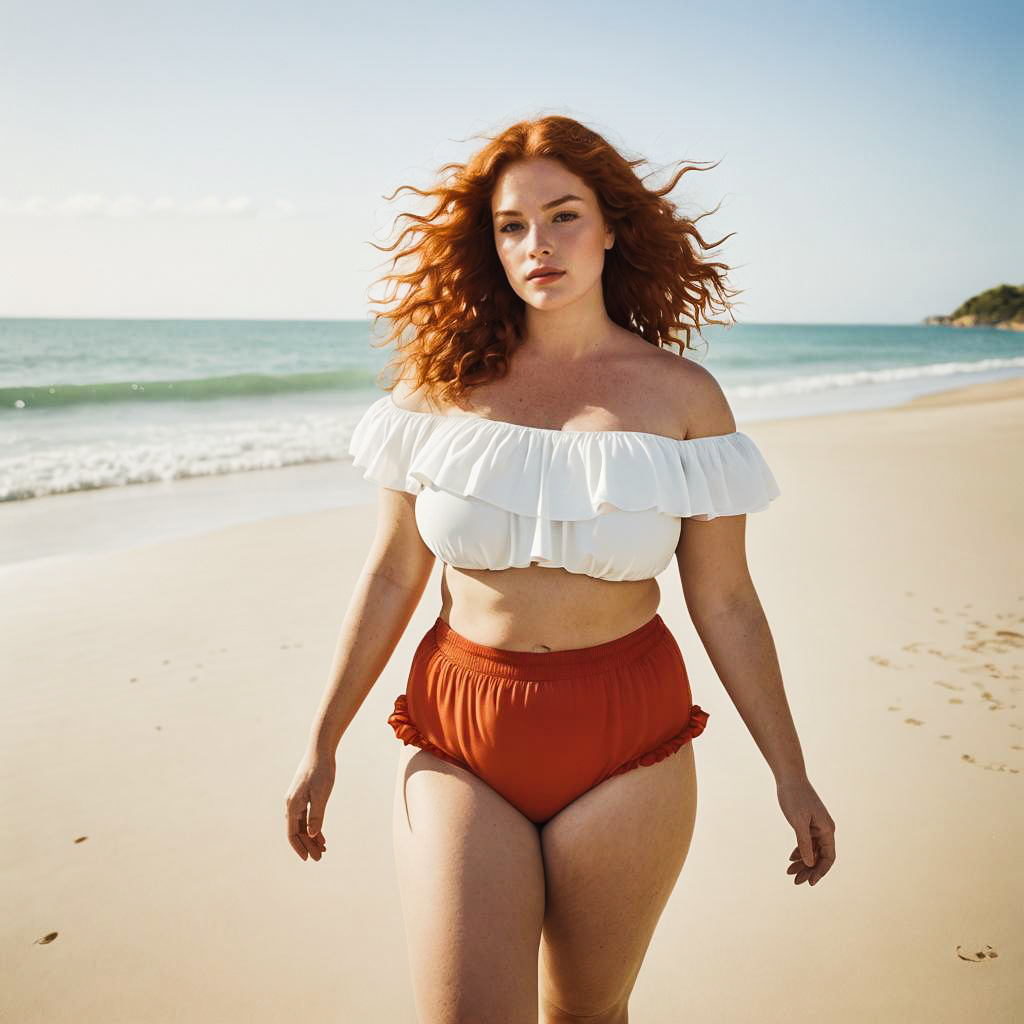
[371,116,738,404]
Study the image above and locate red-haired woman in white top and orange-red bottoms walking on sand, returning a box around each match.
[287,117,835,1024]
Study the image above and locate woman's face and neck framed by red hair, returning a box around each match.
[490,157,616,362]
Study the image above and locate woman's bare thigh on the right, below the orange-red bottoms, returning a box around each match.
[540,742,697,1021]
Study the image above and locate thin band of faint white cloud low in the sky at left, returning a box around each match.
[0,193,298,219]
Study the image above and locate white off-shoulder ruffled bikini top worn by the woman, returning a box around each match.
[348,393,779,581]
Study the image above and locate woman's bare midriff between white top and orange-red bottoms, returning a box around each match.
[440,565,662,652]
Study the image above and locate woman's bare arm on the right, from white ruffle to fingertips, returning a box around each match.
[676,515,836,886]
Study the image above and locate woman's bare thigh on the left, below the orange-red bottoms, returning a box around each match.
[393,745,544,1024]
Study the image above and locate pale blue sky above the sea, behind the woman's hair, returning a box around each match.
[0,0,1024,324]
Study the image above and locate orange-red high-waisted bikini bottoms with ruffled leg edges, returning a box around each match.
[388,614,708,824]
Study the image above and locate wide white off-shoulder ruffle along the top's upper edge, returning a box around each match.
[348,394,780,521]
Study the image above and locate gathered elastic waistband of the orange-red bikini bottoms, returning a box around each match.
[431,613,669,679]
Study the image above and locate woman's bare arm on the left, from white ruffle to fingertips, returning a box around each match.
[286,487,434,860]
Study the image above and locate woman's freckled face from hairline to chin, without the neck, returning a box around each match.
[490,157,614,309]
